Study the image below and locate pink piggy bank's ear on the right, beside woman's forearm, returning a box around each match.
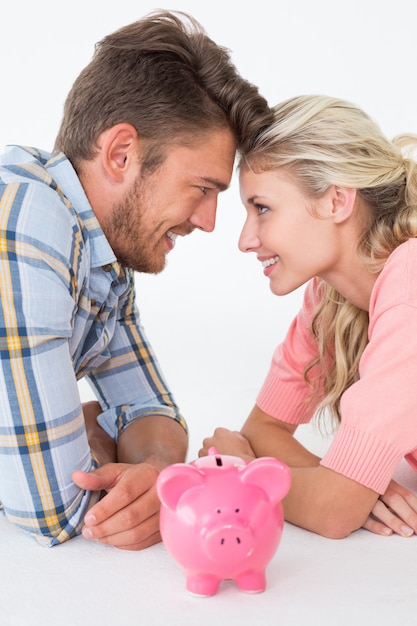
[241,457,291,502]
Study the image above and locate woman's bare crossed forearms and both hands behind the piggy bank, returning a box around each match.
[200,406,417,538]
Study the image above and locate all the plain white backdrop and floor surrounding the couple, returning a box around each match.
[0,6,417,626]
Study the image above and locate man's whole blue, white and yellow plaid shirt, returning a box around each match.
[0,146,186,546]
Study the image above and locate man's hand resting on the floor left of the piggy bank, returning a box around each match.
[72,463,161,550]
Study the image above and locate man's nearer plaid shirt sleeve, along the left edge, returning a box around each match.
[0,178,99,546]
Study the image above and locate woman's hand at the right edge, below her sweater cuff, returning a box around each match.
[363,480,417,537]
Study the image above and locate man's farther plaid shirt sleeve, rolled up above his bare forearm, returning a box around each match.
[88,278,187,441]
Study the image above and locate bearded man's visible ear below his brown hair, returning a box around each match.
[98,123,138,183]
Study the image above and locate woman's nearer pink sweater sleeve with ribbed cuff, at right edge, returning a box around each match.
[321,240,417,493]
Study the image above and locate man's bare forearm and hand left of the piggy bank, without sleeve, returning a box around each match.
[73,415,188,550]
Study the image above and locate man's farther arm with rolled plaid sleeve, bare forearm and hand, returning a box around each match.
[73,266,188,550]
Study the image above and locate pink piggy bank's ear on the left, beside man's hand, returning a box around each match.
[156,463,205,511]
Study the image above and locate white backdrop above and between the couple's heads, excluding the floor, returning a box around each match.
[0,0,417,456]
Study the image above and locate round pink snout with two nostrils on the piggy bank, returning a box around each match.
[203,523,254,566]
